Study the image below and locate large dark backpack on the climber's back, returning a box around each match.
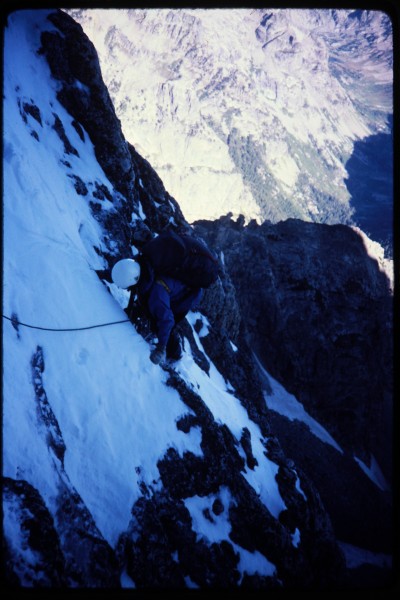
[141,230,219,288]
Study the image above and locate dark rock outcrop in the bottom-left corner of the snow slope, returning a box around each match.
[2,477,120,589]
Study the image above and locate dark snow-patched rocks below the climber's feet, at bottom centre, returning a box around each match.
[116,369,345,589]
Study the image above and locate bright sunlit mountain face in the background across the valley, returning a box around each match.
[68,8,393,256]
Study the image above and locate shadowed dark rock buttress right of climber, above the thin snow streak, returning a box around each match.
[196,218,393,480]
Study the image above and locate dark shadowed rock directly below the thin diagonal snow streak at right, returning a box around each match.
[269,411,394,554]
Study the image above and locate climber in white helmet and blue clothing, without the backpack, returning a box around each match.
[112,235,202,364]
